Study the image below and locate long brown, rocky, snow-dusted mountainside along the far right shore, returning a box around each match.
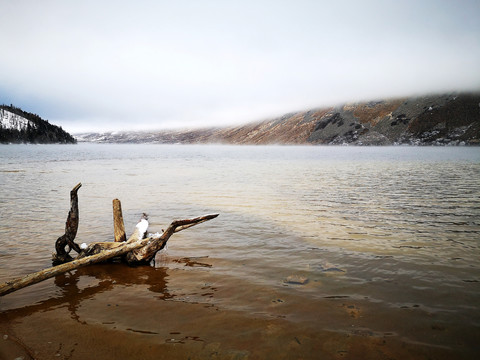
[77,94,480,145]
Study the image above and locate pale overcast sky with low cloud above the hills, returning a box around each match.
[0,0,480,133]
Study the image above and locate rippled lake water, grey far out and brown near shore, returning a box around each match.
[0,144,480,359]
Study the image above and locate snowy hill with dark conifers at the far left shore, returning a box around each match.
[0,105,76,144]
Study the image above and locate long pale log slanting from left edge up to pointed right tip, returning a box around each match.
[0,214,218,296]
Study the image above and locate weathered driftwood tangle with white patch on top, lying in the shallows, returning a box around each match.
[0,184,218,296]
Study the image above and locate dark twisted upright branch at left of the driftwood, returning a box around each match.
[52,183,82,265]
